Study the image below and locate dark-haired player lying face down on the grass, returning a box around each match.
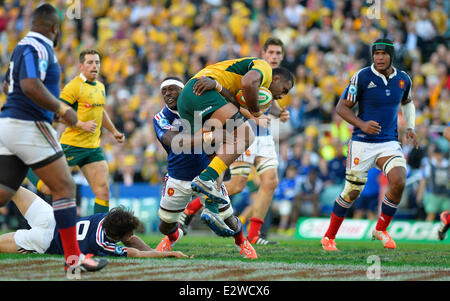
[0,187,188,258]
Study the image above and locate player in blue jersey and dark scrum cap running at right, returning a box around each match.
[321,39,419,251]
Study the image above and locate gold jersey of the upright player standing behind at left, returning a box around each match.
[60,74,106,148]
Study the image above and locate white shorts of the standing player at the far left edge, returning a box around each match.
[0,118,62,165]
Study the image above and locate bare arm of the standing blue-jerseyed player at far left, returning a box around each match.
[20,78,78,126]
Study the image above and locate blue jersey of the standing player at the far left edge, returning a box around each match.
[0,32,61,123]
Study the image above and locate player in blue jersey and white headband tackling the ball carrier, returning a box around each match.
[153,77,257,259]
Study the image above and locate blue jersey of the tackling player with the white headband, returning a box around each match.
[153,106,209,181]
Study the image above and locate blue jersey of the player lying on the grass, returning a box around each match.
[45,213,128,257]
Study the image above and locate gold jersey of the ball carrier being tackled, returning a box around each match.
[193,57,272,95]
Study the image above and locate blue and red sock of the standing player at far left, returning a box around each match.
[52,199,81,263]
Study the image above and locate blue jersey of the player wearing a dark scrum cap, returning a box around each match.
[341,64,412,143]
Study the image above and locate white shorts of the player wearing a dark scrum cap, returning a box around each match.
[347,140,404,172]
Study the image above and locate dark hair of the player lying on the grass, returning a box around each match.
[103,205,141,241]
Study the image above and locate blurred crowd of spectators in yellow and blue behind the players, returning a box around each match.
[0,0,450,231]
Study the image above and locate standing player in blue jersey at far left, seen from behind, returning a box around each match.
[0,4,108,271]
